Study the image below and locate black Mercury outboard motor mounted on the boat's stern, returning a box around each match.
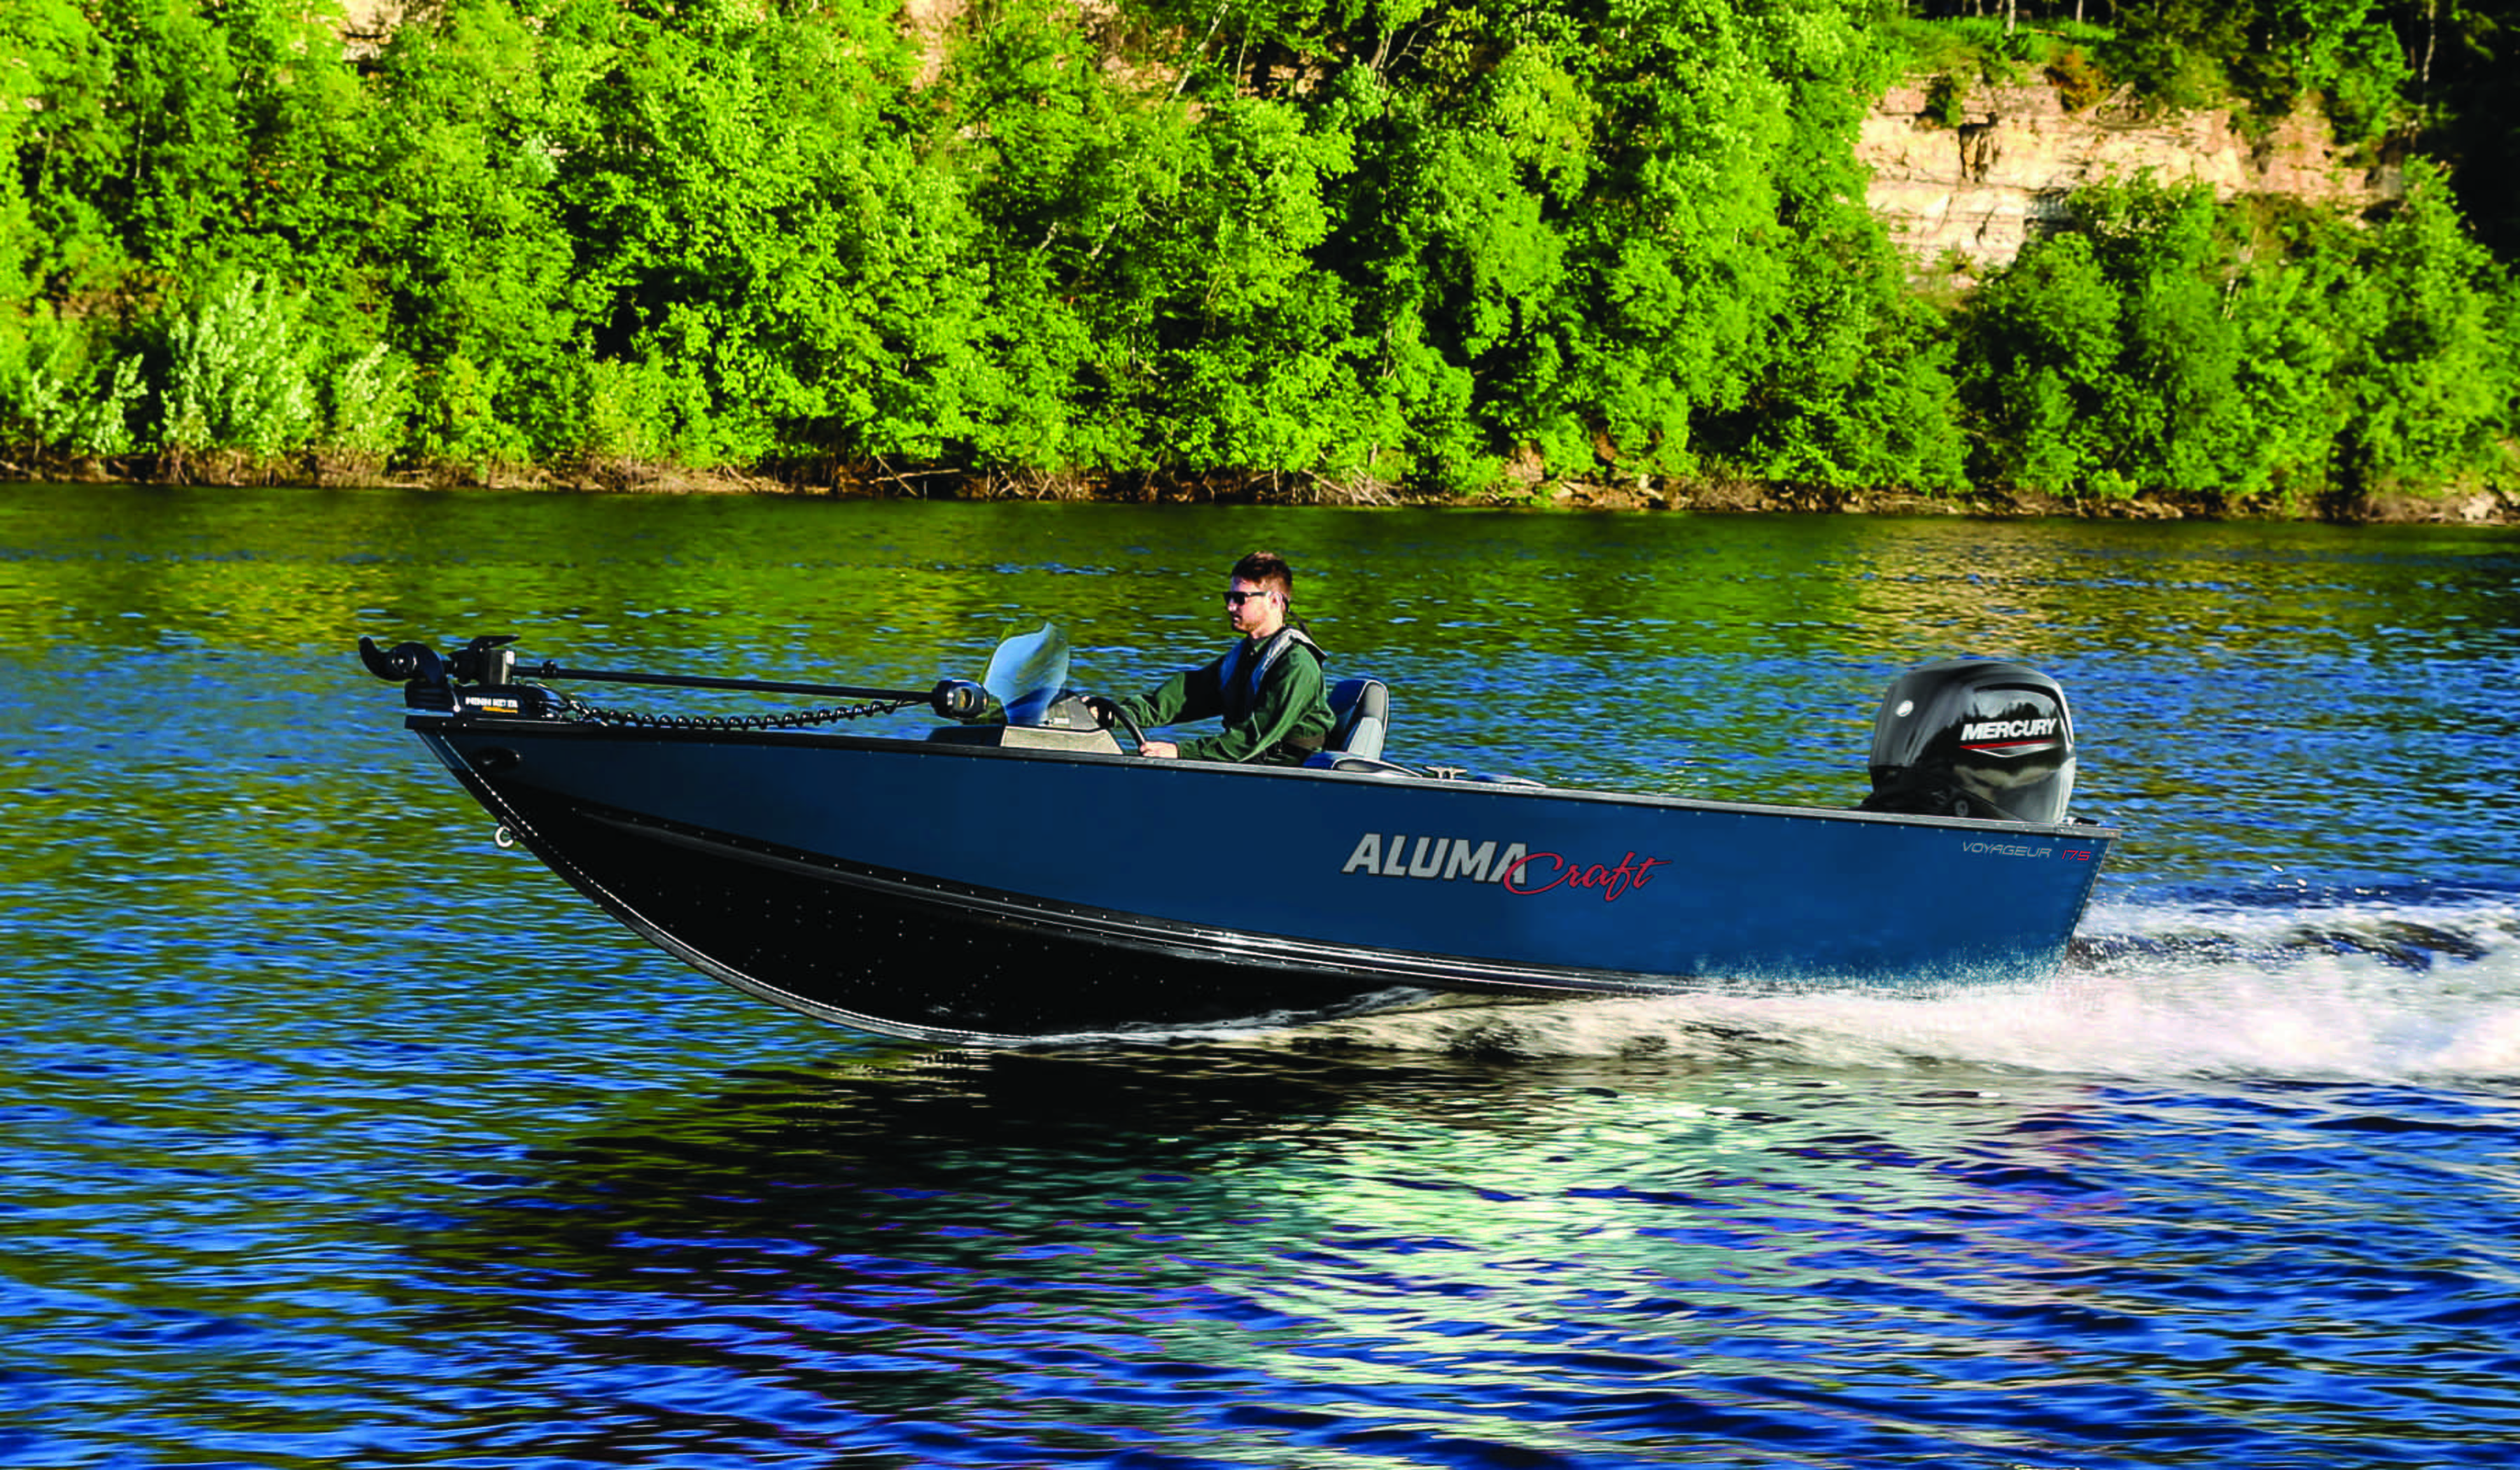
[1862,658,2074,822]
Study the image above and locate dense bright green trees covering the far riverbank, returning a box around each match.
[0,0,2520,502]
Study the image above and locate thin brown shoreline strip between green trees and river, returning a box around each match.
[0,456,2520,527]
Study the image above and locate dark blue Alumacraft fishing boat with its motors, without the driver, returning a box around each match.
[360,625,2117,1044]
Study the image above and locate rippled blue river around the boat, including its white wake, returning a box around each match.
[0,486,2520,1470]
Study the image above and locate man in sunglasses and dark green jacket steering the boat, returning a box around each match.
[1096,552,1331,766]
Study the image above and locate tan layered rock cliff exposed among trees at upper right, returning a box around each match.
[1855,80,2399,275]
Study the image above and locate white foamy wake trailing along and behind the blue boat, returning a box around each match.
[1210,890,2520,1082]
